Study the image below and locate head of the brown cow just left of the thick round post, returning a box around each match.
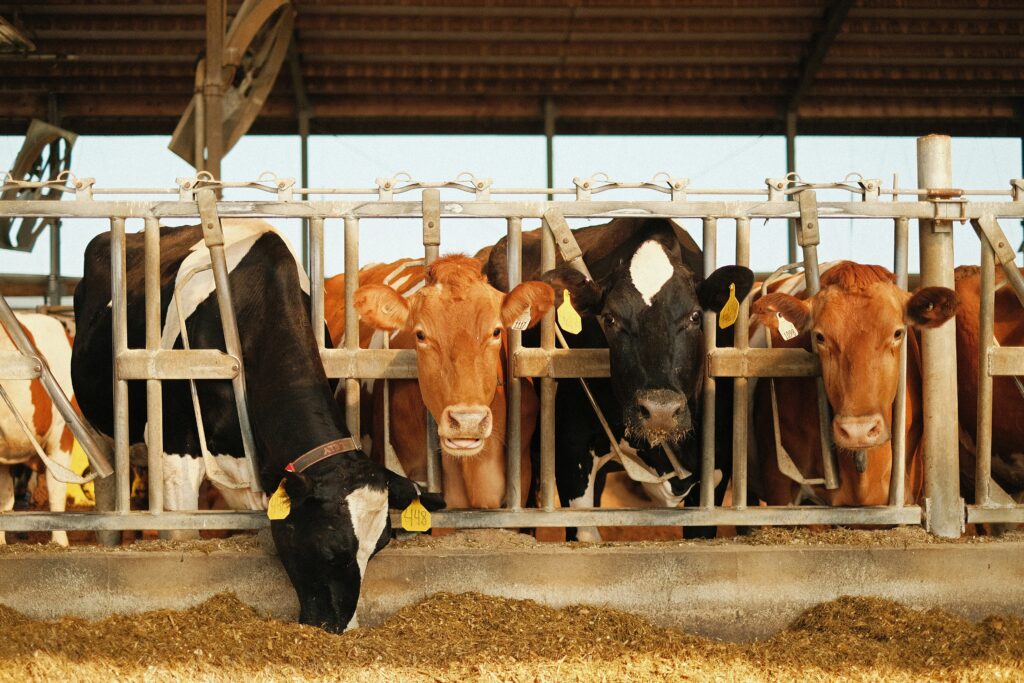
[752,261,957,451]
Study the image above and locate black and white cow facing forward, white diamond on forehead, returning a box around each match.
[484,218,754,540]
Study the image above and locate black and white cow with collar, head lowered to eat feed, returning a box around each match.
[72,220,443,632]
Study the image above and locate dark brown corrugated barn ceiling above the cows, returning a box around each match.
[0,0,1024,135]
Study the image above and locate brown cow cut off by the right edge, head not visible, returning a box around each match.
[955,266,1024,501]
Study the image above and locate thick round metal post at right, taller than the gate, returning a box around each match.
[918,135,964,538]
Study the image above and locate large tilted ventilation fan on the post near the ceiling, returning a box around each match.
[168,0,295,169]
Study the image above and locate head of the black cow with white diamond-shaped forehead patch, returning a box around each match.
[544,239,754,445]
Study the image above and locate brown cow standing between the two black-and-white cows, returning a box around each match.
[326,256,554,508]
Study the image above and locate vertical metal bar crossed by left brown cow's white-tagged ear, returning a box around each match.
[505,217,522,510]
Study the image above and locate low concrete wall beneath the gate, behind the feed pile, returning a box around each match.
[0,542,1024,640]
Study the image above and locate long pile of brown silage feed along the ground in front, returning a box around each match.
[0,593,1024,682]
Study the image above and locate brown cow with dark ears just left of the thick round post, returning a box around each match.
[752,261,956,506]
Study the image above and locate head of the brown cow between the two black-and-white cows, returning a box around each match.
[355,256,554,457]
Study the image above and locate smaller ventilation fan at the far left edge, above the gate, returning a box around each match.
[0,119,78,251]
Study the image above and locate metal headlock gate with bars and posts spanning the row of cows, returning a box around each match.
[0,136,1024,537]
